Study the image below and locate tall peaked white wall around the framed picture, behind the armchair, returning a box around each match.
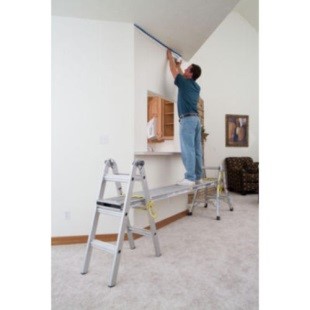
[190,12,259,165]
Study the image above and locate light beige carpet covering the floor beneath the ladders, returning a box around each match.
[52,194,259,310]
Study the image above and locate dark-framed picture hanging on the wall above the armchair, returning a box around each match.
[225,114,249,147]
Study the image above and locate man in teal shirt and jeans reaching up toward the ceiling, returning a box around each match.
[167,50,202,186]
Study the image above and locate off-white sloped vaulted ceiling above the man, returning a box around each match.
[52,0,258,60]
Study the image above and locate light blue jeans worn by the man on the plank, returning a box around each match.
[180,116,202,181]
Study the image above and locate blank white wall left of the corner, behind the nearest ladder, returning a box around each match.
[52,17,134,237]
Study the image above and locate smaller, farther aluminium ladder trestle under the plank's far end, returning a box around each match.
[188,165,234,220]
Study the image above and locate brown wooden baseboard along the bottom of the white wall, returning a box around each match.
[52,211,188,245]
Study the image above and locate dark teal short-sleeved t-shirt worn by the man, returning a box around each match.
[174,74,200,117]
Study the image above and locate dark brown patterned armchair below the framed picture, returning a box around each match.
[225,157,259,195]
